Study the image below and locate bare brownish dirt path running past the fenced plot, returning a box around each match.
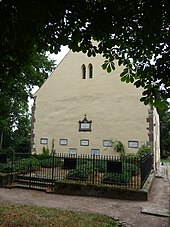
[0,177,170,227]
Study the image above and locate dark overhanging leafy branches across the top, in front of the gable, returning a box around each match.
[0,0,170,111]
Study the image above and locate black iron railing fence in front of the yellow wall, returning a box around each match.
[0,153,152,189]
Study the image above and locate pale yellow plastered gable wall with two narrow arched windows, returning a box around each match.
[33,51,148,155]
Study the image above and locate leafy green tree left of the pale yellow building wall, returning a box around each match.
[0,43,54,149]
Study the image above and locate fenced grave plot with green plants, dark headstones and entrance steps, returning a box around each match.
[0,153,152,197]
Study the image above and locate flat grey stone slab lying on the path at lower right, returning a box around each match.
[141,207,170,217]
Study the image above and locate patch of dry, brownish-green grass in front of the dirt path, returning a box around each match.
[0,205,121,227]
